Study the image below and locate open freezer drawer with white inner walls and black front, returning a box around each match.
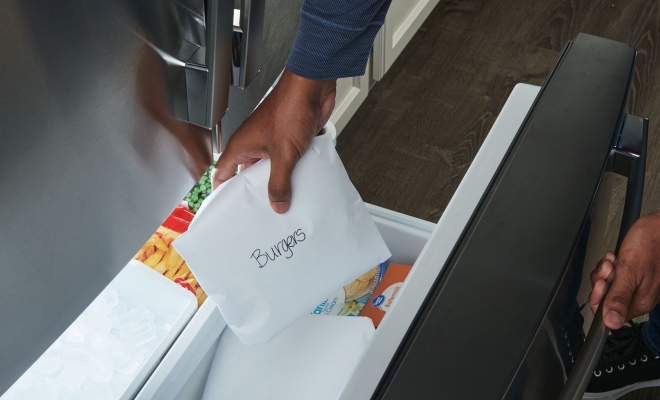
[137,34,636,400]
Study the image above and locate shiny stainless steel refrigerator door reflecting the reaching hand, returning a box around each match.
[0,0,233,394]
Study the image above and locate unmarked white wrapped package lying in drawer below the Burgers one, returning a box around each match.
[202,315,375,400]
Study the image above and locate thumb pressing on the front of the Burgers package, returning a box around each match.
[268,149,299,214]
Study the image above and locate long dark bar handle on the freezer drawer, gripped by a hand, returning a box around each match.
[558,114,649,400]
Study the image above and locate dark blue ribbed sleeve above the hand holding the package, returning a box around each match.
[285,0,392,80]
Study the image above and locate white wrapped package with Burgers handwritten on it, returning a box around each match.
[174,136,390,345]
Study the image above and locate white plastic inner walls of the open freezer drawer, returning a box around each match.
[137,84,540,400]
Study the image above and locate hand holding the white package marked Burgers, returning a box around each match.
[213,70,337,214]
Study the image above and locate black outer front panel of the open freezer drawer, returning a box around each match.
[374,34,636,400]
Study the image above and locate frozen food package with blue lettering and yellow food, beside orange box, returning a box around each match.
[311,263,385,316]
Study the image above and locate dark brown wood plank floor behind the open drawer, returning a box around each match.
[337,0,660,400]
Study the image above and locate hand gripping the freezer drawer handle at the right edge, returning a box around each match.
[589,210,660,329]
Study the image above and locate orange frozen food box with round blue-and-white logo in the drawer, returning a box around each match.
[360,264,412,328]
